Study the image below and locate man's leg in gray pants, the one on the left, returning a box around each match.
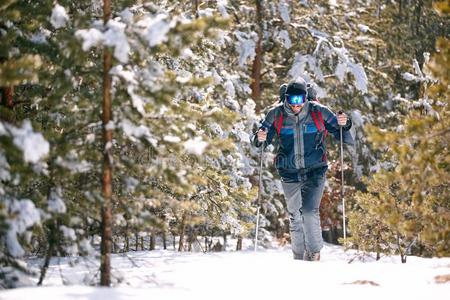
[282,182,305,259]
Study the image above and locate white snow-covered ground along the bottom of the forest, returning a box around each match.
[0,245,450,300]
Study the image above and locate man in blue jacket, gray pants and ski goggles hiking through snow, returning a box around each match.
[253,79,354,261]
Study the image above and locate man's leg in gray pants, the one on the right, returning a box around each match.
[302,174,325,260]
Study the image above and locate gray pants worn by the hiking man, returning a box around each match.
[282,172,325,259]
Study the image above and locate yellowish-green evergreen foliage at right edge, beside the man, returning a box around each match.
[350,11,450,256]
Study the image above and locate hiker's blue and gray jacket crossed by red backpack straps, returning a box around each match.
[253,101,354,181]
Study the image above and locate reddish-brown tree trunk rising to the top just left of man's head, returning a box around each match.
[251,0,263,112]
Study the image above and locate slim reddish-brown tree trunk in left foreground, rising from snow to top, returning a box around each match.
[100,0,112,286]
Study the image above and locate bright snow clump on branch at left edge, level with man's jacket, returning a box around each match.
[8,120,50,163]
